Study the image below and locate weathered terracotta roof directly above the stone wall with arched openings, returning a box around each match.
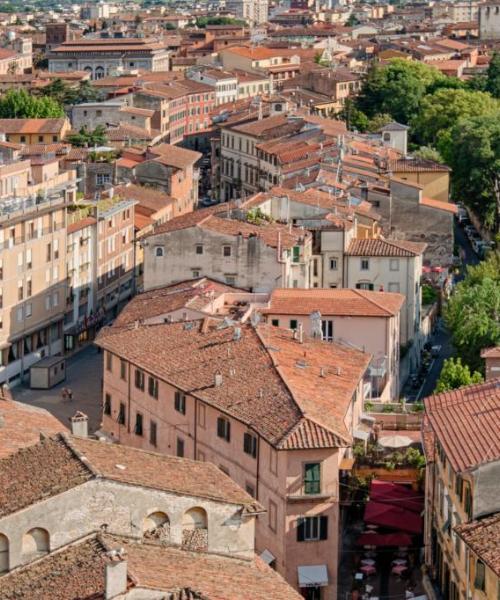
[0,434,257,516]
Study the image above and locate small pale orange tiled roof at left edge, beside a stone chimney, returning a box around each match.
[0,398,66,458]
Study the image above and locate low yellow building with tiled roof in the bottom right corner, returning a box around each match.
[456,513,500,600]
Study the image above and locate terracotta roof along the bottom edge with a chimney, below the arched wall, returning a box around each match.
[0,534,301,600]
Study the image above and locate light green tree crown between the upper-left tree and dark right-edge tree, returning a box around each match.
[412,88,500,152]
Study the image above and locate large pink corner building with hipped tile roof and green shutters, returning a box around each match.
[98,314,371,600]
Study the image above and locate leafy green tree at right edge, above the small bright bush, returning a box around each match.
[444,251,500,369]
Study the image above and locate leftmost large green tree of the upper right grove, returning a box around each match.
[356,58,446,124]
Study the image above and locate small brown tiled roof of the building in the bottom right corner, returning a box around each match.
[455,513,500,577]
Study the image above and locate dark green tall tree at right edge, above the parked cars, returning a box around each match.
[443,112,500,230]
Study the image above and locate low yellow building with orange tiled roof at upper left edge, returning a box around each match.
[0,117,71,144]
